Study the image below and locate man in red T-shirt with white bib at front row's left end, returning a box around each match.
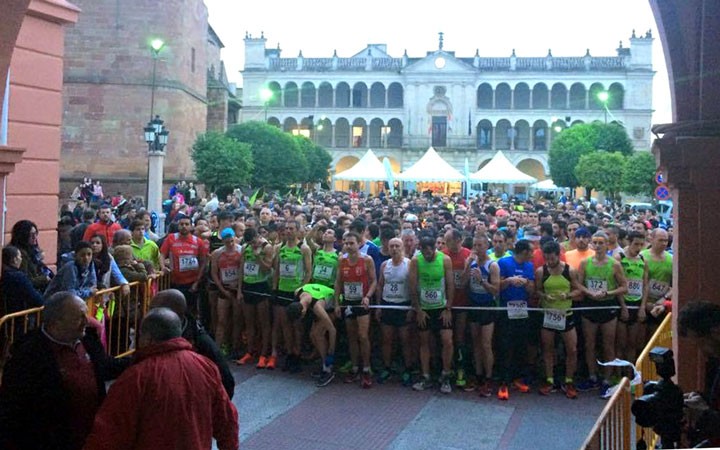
[160,217,209,314]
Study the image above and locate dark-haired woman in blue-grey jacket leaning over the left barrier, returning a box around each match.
[45,241,97,300]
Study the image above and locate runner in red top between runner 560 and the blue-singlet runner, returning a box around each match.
[442,228,472,387]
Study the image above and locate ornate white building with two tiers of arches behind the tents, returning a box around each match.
[241,31,654,188]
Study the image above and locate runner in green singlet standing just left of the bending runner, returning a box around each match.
[270,220,312,373]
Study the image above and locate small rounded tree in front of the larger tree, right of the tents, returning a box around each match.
[575,152,625,199]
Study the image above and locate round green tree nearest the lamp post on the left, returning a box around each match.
[192,131,253,196]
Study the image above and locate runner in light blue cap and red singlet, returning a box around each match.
[210,227,242,358]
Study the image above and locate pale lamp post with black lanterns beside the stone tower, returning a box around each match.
[143,116,170,234]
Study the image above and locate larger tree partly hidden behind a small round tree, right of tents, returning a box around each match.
[548,123,633,188]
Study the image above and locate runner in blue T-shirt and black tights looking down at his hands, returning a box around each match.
[496,239,535,400]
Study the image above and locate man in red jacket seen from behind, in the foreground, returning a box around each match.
[85,308,240,450]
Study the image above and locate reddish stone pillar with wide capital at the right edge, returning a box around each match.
[653,126,720,392]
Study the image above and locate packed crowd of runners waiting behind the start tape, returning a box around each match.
[62,192,673,400]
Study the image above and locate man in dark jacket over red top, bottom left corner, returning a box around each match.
[0,292,129,450]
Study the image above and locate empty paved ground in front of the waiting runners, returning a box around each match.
[222,366,605,450]
